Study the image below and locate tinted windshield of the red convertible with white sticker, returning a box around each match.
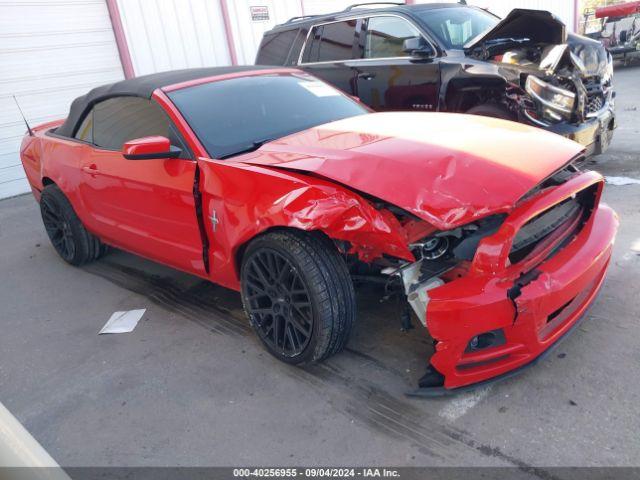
[168,73,369,158]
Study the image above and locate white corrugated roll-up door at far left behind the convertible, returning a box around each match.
[0,0,124,198]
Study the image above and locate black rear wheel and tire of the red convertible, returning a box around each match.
[40,185,107,266]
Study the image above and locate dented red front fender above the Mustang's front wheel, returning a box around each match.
[198,158,415,290]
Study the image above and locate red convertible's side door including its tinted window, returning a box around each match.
[76,97,204,274]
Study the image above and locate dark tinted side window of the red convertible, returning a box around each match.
[75,97,187,155]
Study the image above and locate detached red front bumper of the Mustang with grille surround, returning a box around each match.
[411,172,618,396]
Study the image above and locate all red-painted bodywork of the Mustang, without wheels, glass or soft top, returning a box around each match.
[21,70,617,388]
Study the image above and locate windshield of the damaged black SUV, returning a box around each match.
[416,7,500,49]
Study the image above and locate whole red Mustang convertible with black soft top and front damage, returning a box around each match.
[21,67,617,395]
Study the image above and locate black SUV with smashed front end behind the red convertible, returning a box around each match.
[256,2,616,155]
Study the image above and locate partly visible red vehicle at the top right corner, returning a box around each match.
[587,2,640,65]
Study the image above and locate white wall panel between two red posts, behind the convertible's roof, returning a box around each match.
[118,0,231,75]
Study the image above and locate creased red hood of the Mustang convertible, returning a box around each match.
[234,112,582,230]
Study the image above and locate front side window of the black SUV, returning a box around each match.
[364,16,422,58]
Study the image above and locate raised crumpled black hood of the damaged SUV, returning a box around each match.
[464,8,567,49]
